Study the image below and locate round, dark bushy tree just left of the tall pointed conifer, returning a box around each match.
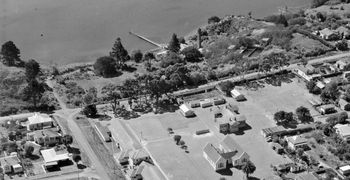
[93,56,117,78]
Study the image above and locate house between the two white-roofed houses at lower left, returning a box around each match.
[27,128,62,146]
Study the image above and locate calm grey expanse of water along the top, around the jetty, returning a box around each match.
[0,0,311,64]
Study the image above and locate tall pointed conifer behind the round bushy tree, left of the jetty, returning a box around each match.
[109,37,130,68]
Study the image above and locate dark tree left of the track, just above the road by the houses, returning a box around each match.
[23,79,45,108]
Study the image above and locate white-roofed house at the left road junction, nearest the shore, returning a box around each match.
[27,113,54,131]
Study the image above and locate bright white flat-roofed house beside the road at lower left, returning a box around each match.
[40,148,70,168]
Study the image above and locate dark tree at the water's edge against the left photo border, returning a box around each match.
[0,41,24,66]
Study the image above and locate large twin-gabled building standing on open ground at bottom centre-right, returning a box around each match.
[203,136,249,171]
